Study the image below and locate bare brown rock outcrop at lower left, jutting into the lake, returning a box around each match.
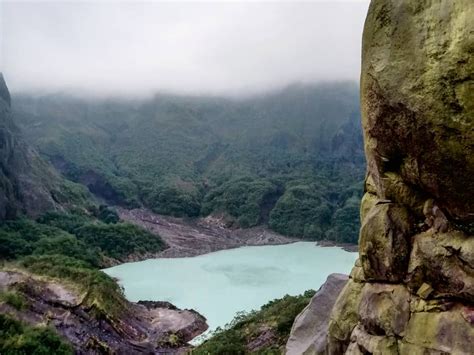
[0,270,208,355]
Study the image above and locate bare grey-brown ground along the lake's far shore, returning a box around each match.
[118,208,299,261]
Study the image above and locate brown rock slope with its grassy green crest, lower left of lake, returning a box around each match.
[0,268,207,354]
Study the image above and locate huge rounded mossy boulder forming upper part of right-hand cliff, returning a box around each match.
[361,0,474,221]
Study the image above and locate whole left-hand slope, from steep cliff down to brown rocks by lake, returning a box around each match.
[0,74,207,354]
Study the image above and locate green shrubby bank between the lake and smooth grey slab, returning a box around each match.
[192,290,315,355]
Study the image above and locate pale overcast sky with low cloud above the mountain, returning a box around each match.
[0,0,369,95]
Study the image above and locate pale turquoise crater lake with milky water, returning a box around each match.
[104,242,357,338]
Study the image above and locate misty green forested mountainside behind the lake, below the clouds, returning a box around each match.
[13,82,365,242]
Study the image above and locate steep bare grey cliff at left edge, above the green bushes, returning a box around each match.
[0,73,87,220]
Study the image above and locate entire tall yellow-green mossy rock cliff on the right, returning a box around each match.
[288,0,474,354]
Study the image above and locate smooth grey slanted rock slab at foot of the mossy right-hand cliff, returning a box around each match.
[286,274,349,355]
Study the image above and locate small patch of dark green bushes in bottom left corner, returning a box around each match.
[0,314,74,355]
